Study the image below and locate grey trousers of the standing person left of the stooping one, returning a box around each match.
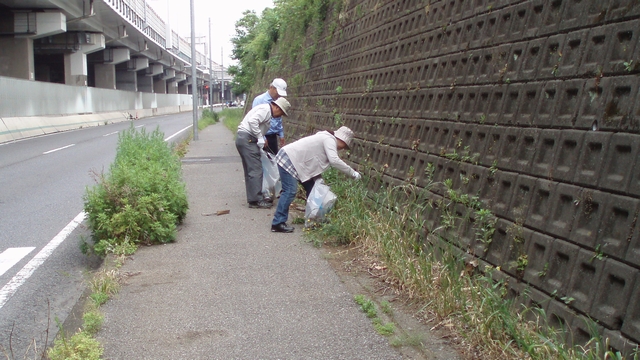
[236,131,263,202]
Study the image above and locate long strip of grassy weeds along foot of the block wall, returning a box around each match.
[305,170,632,359]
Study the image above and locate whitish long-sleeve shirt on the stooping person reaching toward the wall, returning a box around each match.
[282,131,356,182]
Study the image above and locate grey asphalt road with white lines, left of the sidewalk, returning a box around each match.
[0,112,193,359]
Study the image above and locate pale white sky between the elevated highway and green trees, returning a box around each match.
[147,0,273,67]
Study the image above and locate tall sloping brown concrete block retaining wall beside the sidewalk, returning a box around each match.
[262,0,640,352]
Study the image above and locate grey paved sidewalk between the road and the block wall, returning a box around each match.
[98,123,401,360]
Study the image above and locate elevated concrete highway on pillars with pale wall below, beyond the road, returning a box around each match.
[0,0,230,142]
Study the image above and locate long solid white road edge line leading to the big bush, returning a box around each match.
[0,211,87,309]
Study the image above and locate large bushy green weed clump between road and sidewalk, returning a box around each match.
[84,127,188,256]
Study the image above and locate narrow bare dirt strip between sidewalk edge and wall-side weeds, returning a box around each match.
[320,245,471,360]
